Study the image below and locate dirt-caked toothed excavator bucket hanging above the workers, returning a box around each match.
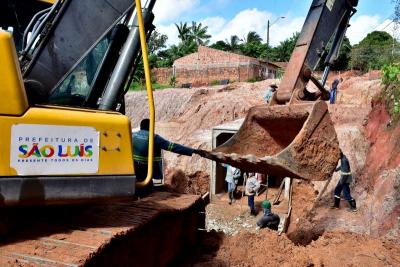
[207,101,339,181]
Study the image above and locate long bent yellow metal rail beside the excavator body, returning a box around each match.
[135,0,155,187]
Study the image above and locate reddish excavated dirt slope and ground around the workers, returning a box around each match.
[127,72,400,266]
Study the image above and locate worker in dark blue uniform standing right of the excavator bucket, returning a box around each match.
[331,150,357,212]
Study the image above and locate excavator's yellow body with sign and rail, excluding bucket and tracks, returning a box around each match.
[0,0,159,206]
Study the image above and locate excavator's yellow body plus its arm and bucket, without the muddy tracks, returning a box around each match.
[0,0,357,206]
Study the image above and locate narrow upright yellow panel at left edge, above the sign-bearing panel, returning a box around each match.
[0,30,29,116]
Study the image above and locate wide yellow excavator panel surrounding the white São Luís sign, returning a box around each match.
[0,106,134,176]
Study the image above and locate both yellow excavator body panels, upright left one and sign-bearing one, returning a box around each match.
[0,31,134,176]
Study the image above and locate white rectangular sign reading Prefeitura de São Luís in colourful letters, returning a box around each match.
[10,124,99,175]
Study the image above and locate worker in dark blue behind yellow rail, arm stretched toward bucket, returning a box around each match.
[132,119,205,186]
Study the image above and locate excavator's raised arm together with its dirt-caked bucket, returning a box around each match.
[207,0,358,180]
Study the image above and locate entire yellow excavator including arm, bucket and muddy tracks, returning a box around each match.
[0,0,357,266]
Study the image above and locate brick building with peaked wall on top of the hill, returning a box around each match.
[153,46,279,86]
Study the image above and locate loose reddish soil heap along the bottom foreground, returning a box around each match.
[179,230,400,267]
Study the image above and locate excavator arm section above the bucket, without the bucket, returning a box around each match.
[275,0,357,104]
